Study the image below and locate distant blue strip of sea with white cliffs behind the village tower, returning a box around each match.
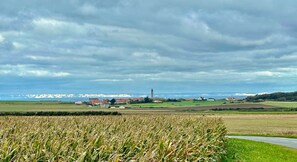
[0,92,256,101]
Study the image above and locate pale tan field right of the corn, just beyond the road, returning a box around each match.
[219,114,297,137]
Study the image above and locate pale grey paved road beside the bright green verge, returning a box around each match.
[227,136,297,149]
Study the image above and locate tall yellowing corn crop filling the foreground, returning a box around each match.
[0,115,226,161]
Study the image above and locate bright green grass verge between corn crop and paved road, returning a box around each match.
[223,139,297,162]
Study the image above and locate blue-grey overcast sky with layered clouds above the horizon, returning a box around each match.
[0,0,297,94]
